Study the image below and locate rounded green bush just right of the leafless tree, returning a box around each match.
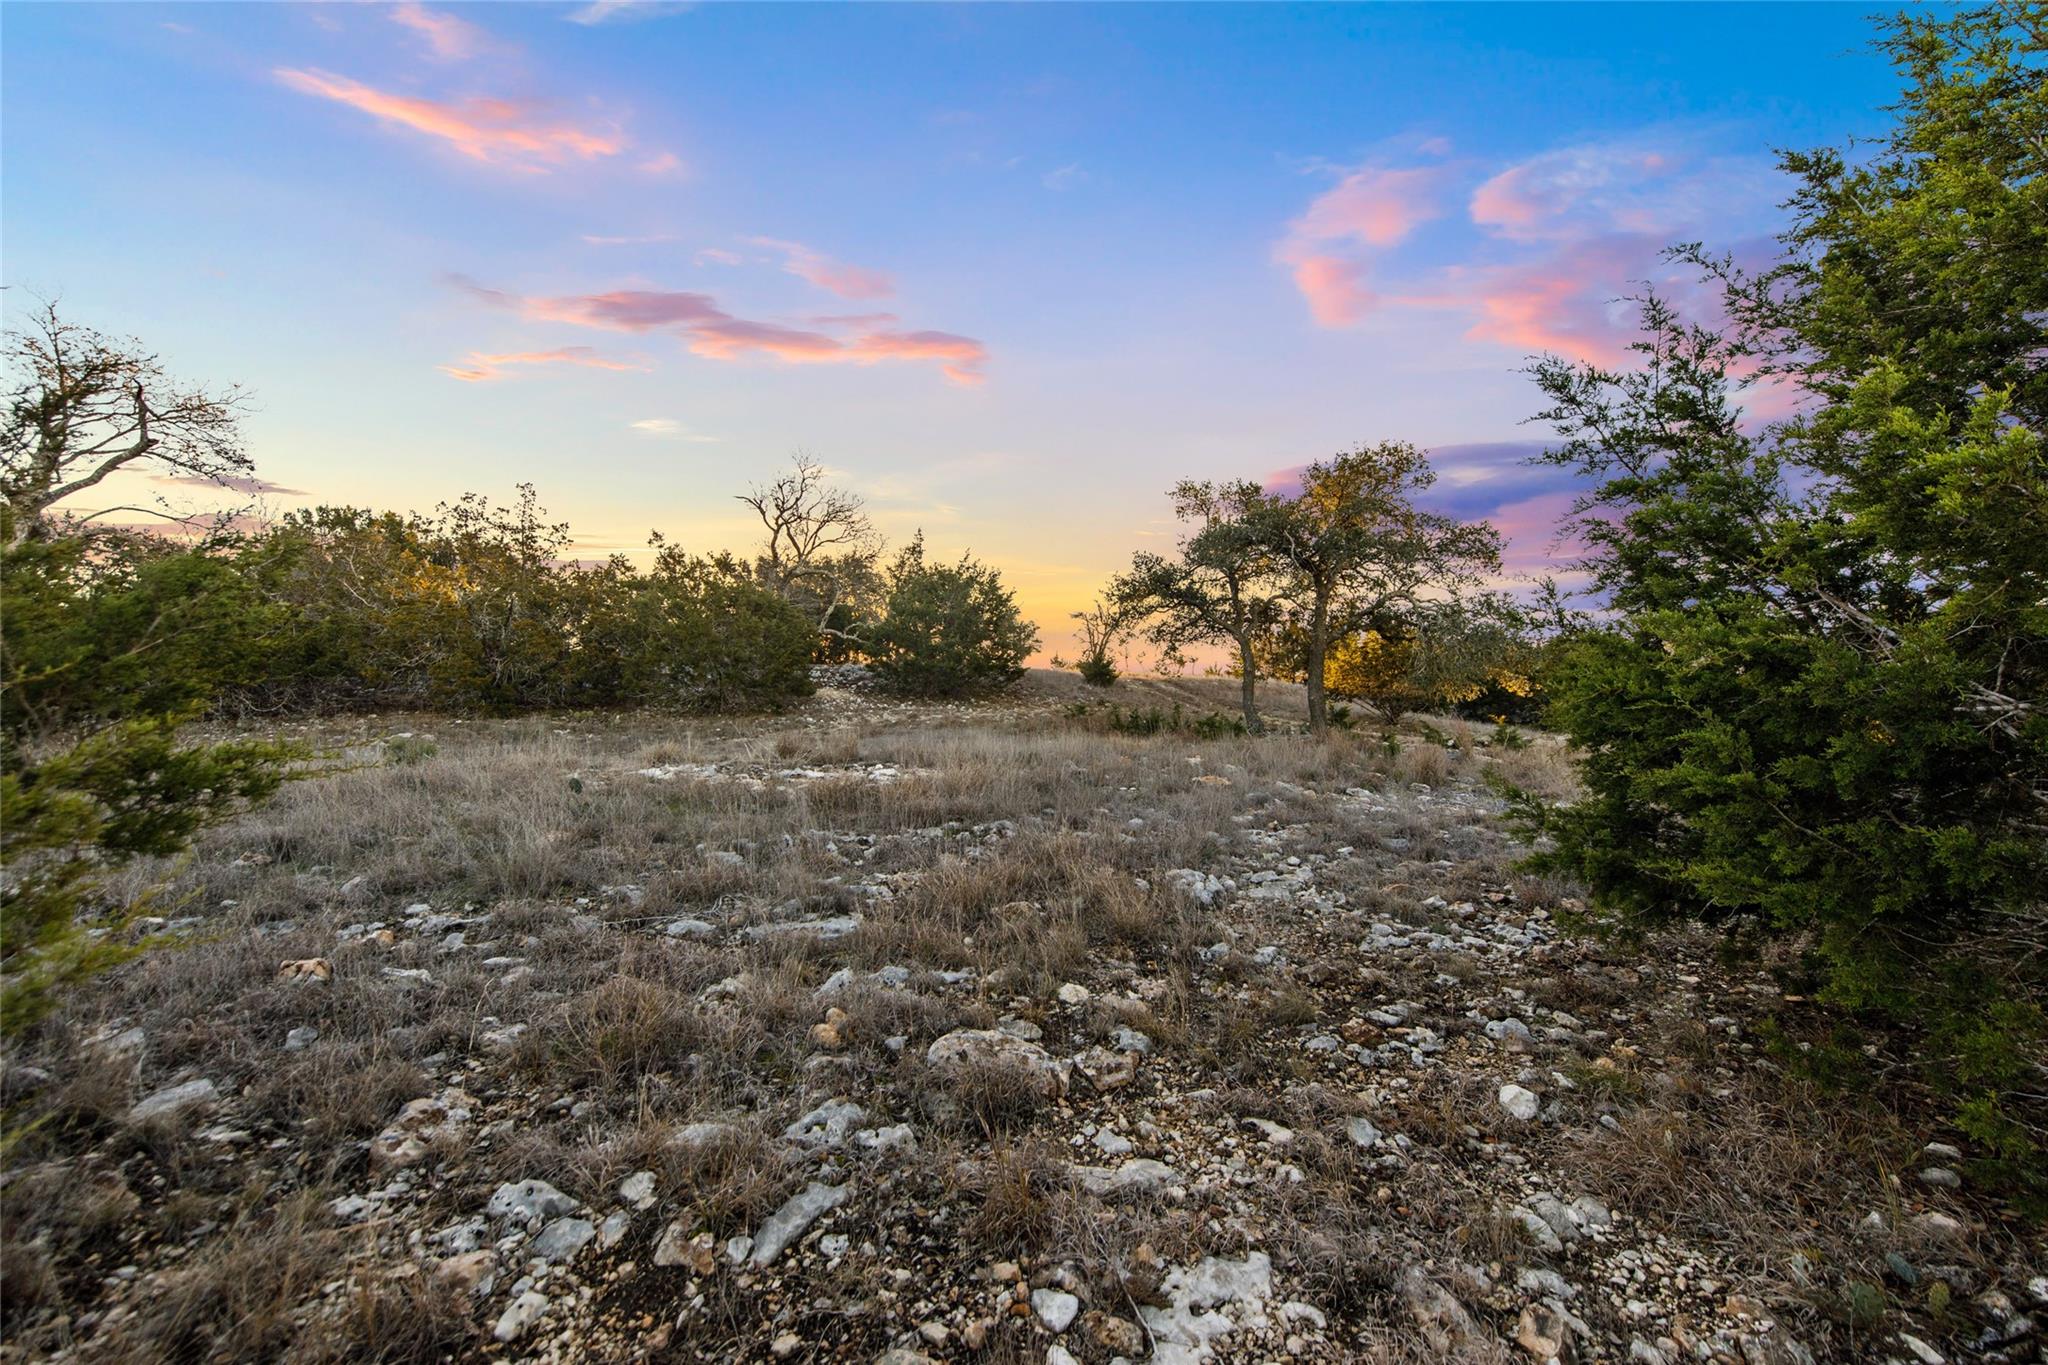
[868,534,1038,696]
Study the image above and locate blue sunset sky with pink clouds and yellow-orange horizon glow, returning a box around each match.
[0,0,1896,647]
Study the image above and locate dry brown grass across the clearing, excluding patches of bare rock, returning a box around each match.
[0,675,2031,1361]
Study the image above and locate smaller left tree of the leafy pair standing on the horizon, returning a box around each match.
[1110,479,1278,735]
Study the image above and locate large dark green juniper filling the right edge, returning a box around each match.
[1536,10,2048,1160]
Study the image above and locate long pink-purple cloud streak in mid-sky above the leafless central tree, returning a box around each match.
[451,276,989,385]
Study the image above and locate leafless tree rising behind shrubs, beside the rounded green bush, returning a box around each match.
[739,450,883,645]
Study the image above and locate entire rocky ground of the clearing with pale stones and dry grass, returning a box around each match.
[0,677,2048,1365]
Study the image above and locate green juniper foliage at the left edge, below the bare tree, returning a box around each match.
[0,512,297,1033]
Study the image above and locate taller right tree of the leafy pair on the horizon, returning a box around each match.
[1247,442,1501,735]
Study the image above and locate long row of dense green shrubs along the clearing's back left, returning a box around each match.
[231,489,817,710]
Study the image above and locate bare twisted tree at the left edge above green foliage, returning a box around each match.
[0,303,254,544]
